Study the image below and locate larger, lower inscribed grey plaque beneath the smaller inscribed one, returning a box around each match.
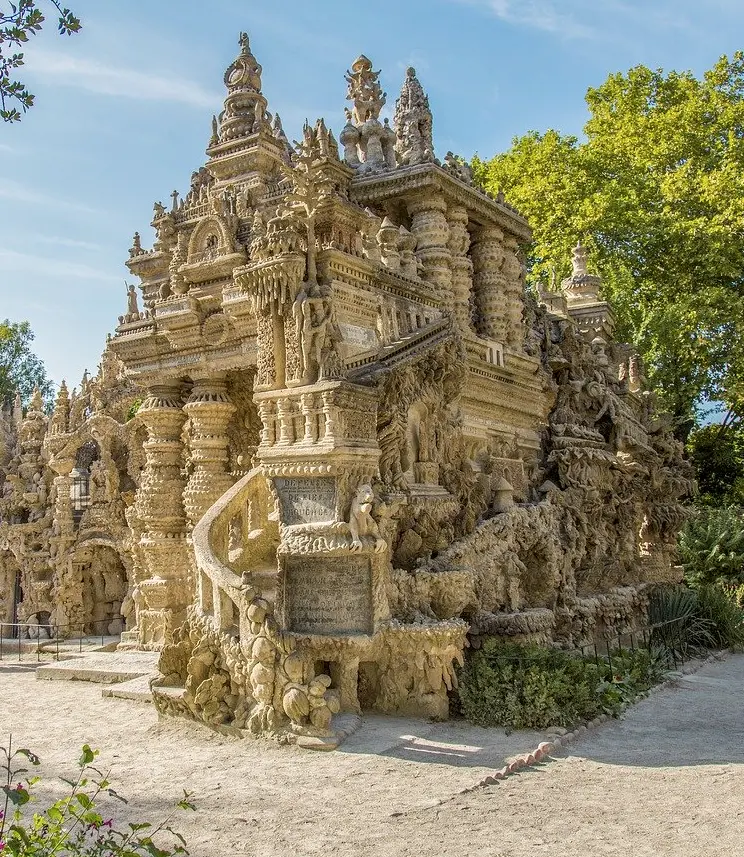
[285,556,372,635]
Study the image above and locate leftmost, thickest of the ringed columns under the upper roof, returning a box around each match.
[408,193,452,308]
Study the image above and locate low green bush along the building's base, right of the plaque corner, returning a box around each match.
[458,639,658,729]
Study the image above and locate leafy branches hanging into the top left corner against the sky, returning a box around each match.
[0,0,81,122]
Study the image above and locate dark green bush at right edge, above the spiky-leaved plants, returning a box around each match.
[679,507,744,587]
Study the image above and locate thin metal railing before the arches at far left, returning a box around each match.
[0,616,125,662]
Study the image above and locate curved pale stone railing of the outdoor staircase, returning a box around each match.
[192,468,279,637]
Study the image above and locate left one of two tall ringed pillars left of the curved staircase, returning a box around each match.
[135,385,192,649]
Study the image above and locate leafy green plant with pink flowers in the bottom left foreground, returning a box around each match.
[0,739,194,857]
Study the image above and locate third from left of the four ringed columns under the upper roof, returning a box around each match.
[470,226,507,342]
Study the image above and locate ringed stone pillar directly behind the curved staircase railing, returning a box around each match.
[183,373,235,527]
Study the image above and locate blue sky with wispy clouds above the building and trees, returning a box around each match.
[0,0,744,392]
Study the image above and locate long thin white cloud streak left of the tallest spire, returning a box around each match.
[24,51,222,109]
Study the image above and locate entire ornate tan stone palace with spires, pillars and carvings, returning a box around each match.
[0,34,691,746]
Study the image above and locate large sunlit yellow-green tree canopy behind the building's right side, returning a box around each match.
[473,52,744,435]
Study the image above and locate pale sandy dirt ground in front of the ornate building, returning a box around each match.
[0,655,744,857]
